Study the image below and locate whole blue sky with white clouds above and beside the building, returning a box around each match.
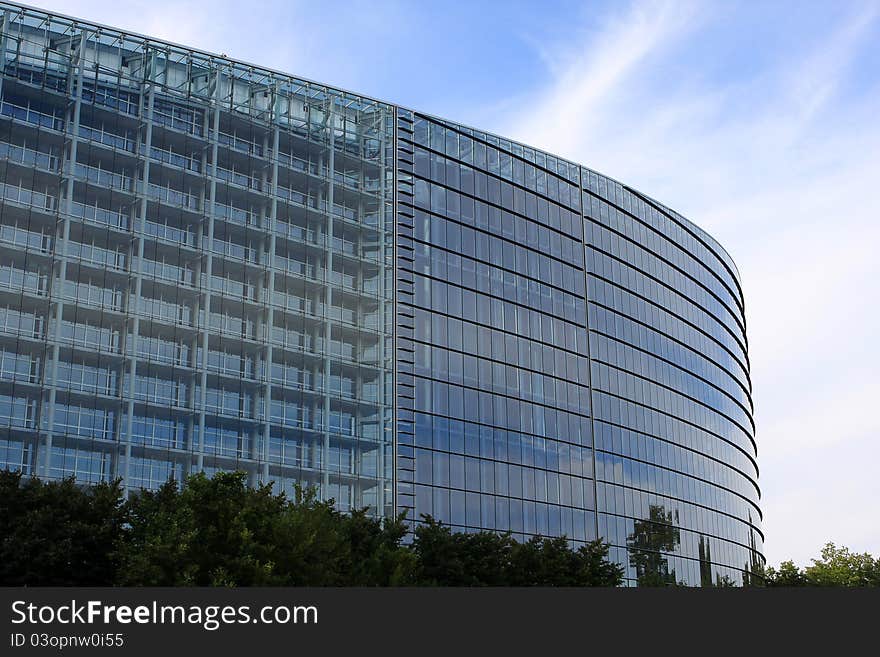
[39,0,880,564]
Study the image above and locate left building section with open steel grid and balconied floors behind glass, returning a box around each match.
[0,4,394,513]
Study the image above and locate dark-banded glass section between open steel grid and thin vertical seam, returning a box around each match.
[398,112,597,543]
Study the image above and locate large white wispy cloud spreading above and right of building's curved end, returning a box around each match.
[501,2,880,562]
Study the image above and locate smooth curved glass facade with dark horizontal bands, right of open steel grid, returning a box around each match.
[397,110,763,585]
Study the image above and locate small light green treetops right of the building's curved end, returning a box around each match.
[766,543,880,587]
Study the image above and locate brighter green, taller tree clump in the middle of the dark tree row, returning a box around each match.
[119,472,412,586]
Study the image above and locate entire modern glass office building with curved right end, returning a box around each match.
[0,3,763,585]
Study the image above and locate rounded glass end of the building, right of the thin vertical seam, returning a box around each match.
[581,169,763,586]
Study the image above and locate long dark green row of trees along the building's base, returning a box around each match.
[0,472,623,586]
